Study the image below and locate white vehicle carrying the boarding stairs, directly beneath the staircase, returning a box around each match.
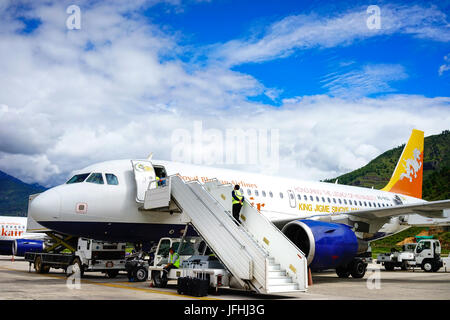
[149,237,231,292]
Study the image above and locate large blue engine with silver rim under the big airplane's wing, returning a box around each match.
[282,220,367,270]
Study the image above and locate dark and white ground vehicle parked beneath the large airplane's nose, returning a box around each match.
[25,235,126,278]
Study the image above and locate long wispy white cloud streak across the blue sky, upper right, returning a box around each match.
[211,4,450,65]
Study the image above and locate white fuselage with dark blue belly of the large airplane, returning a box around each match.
[30,160,424,241]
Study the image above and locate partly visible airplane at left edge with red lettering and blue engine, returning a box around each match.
[0,216,45,256]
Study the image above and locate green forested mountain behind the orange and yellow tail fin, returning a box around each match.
[324,130,450,201]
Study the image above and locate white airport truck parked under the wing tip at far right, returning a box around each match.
[377,239,443,272]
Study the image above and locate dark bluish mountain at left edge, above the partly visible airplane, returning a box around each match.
[0,171,46,217]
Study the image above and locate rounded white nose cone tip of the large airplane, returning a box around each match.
[29,189,61,222]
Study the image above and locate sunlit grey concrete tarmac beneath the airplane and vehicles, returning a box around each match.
[0,256,450,301]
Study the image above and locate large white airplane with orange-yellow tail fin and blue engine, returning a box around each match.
[29,129,450,278]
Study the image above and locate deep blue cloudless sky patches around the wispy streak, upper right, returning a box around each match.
[145,0,450,100]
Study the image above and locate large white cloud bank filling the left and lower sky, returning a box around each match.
[0,1,450,185]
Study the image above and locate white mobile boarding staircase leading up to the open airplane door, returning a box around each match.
[136,175,308,294]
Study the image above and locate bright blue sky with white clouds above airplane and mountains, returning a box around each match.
[0,0,450,186]
